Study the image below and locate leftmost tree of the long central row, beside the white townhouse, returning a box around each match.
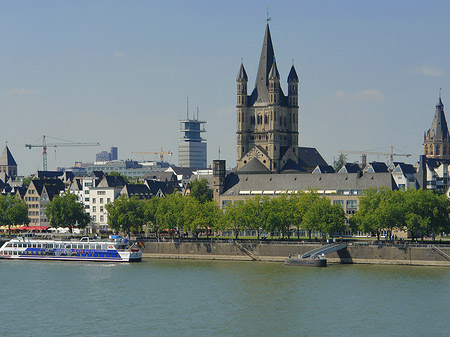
[106,195,145,234]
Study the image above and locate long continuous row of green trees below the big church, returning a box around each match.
[106,186,346,238]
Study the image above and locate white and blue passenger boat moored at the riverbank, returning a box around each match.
[0,233,142,262]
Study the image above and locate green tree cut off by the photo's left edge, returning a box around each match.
[0,194,30,235]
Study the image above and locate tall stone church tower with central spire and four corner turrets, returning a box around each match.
[236,24,299,173]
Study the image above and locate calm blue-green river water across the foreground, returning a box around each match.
[0,260,450,336]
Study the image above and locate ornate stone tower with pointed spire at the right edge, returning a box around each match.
[423,95,450,159]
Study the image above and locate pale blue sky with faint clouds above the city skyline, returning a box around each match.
[0,0,450,175]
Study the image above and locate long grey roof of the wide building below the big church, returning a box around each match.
[222,173,397,195]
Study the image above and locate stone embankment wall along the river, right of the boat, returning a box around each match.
[143,241,450,267]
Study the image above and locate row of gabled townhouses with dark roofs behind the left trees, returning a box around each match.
[7,171,181,231]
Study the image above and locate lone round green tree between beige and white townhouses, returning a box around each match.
[45,193,91,233]
